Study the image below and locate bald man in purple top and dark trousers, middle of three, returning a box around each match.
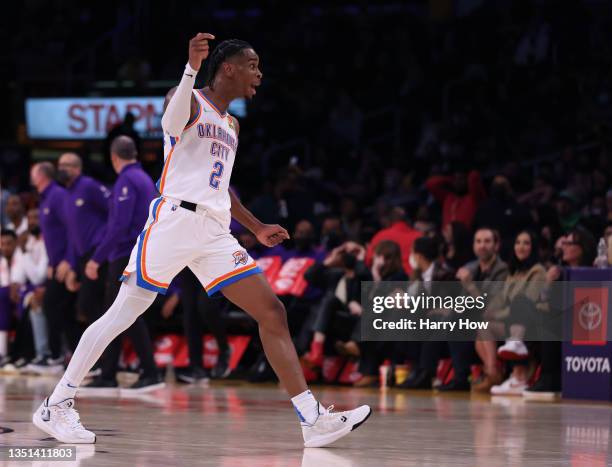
[57,152,111,323]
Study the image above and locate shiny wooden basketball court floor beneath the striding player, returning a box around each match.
[0,376,612,467]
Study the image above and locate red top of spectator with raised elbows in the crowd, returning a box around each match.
[425,170,486,229]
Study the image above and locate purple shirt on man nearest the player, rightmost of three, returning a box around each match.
[92,162,159,263]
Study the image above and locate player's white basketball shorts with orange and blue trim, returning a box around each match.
[120,197,261,295]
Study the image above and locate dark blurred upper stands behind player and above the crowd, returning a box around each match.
[0,0,612,241]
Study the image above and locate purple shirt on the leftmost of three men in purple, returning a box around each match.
[40,182,73,267]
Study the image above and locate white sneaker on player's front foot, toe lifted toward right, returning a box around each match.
[301,403,372,448]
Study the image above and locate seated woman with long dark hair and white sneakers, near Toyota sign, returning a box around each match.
[486,230,546,395]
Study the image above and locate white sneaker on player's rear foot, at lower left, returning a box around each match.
[32,397,96,444]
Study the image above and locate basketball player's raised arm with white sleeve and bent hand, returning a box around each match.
[161,32,215,136]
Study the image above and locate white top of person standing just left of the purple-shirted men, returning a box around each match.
[10,235,49,285]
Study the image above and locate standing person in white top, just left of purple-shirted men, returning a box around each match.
[4,209,51,371]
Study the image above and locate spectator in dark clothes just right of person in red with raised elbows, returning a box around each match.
[473,175,533,258]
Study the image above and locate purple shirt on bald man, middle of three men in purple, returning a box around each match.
[65,175,110,256]
